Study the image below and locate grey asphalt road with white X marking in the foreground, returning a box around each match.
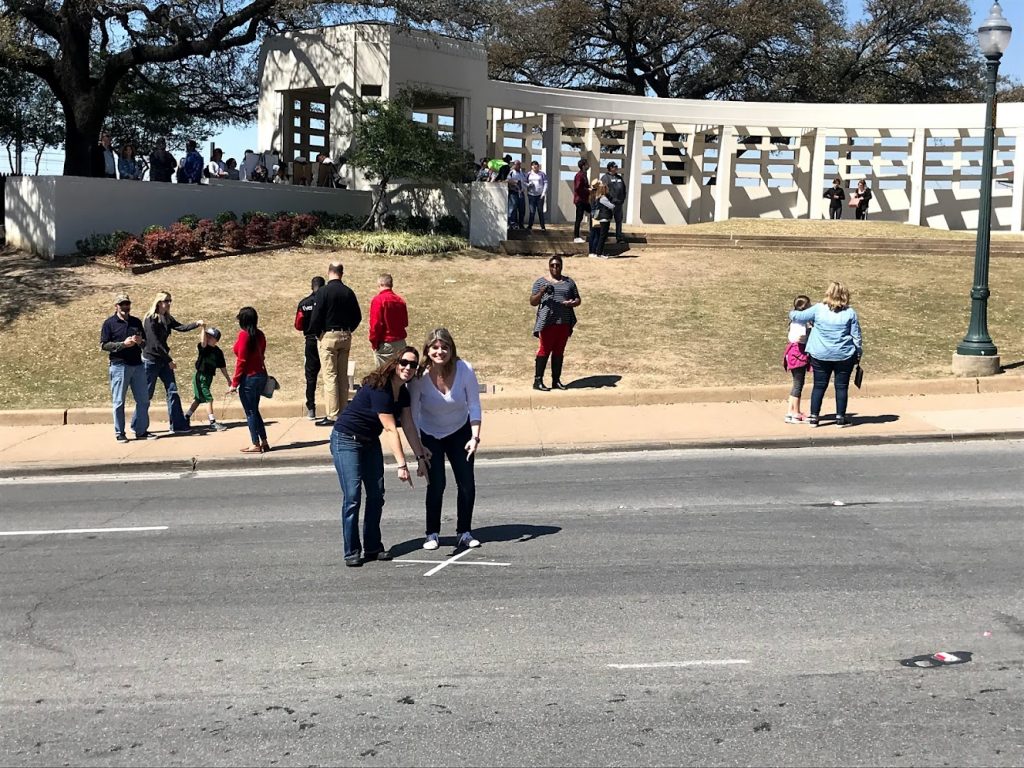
[0,442,1024,766]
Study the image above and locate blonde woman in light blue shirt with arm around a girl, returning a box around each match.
[790,281,863,427]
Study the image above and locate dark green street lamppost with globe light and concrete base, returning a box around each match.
[953,0,1013,376]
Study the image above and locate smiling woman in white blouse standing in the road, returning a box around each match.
[409,328,480,550]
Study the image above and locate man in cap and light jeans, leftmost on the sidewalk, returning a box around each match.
[99,293,156,442]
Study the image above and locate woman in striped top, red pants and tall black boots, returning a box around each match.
[529,255,583,392]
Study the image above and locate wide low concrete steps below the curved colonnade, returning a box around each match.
[502,224,1024,258]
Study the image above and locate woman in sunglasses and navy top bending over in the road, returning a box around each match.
[331,347,430,567]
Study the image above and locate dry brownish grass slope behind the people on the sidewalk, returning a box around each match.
[0,221,1024,409]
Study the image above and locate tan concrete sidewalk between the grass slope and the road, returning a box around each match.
[0,374,1024,477]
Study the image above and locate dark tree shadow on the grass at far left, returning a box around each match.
[0,249,88,329]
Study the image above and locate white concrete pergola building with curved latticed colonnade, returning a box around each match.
[258,24,1024,231]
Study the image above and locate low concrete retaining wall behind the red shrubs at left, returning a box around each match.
[4,176,370,258]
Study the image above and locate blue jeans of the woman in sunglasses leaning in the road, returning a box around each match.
[331,430,384,558]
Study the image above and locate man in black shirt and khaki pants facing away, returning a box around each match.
[309,262,362,424]
